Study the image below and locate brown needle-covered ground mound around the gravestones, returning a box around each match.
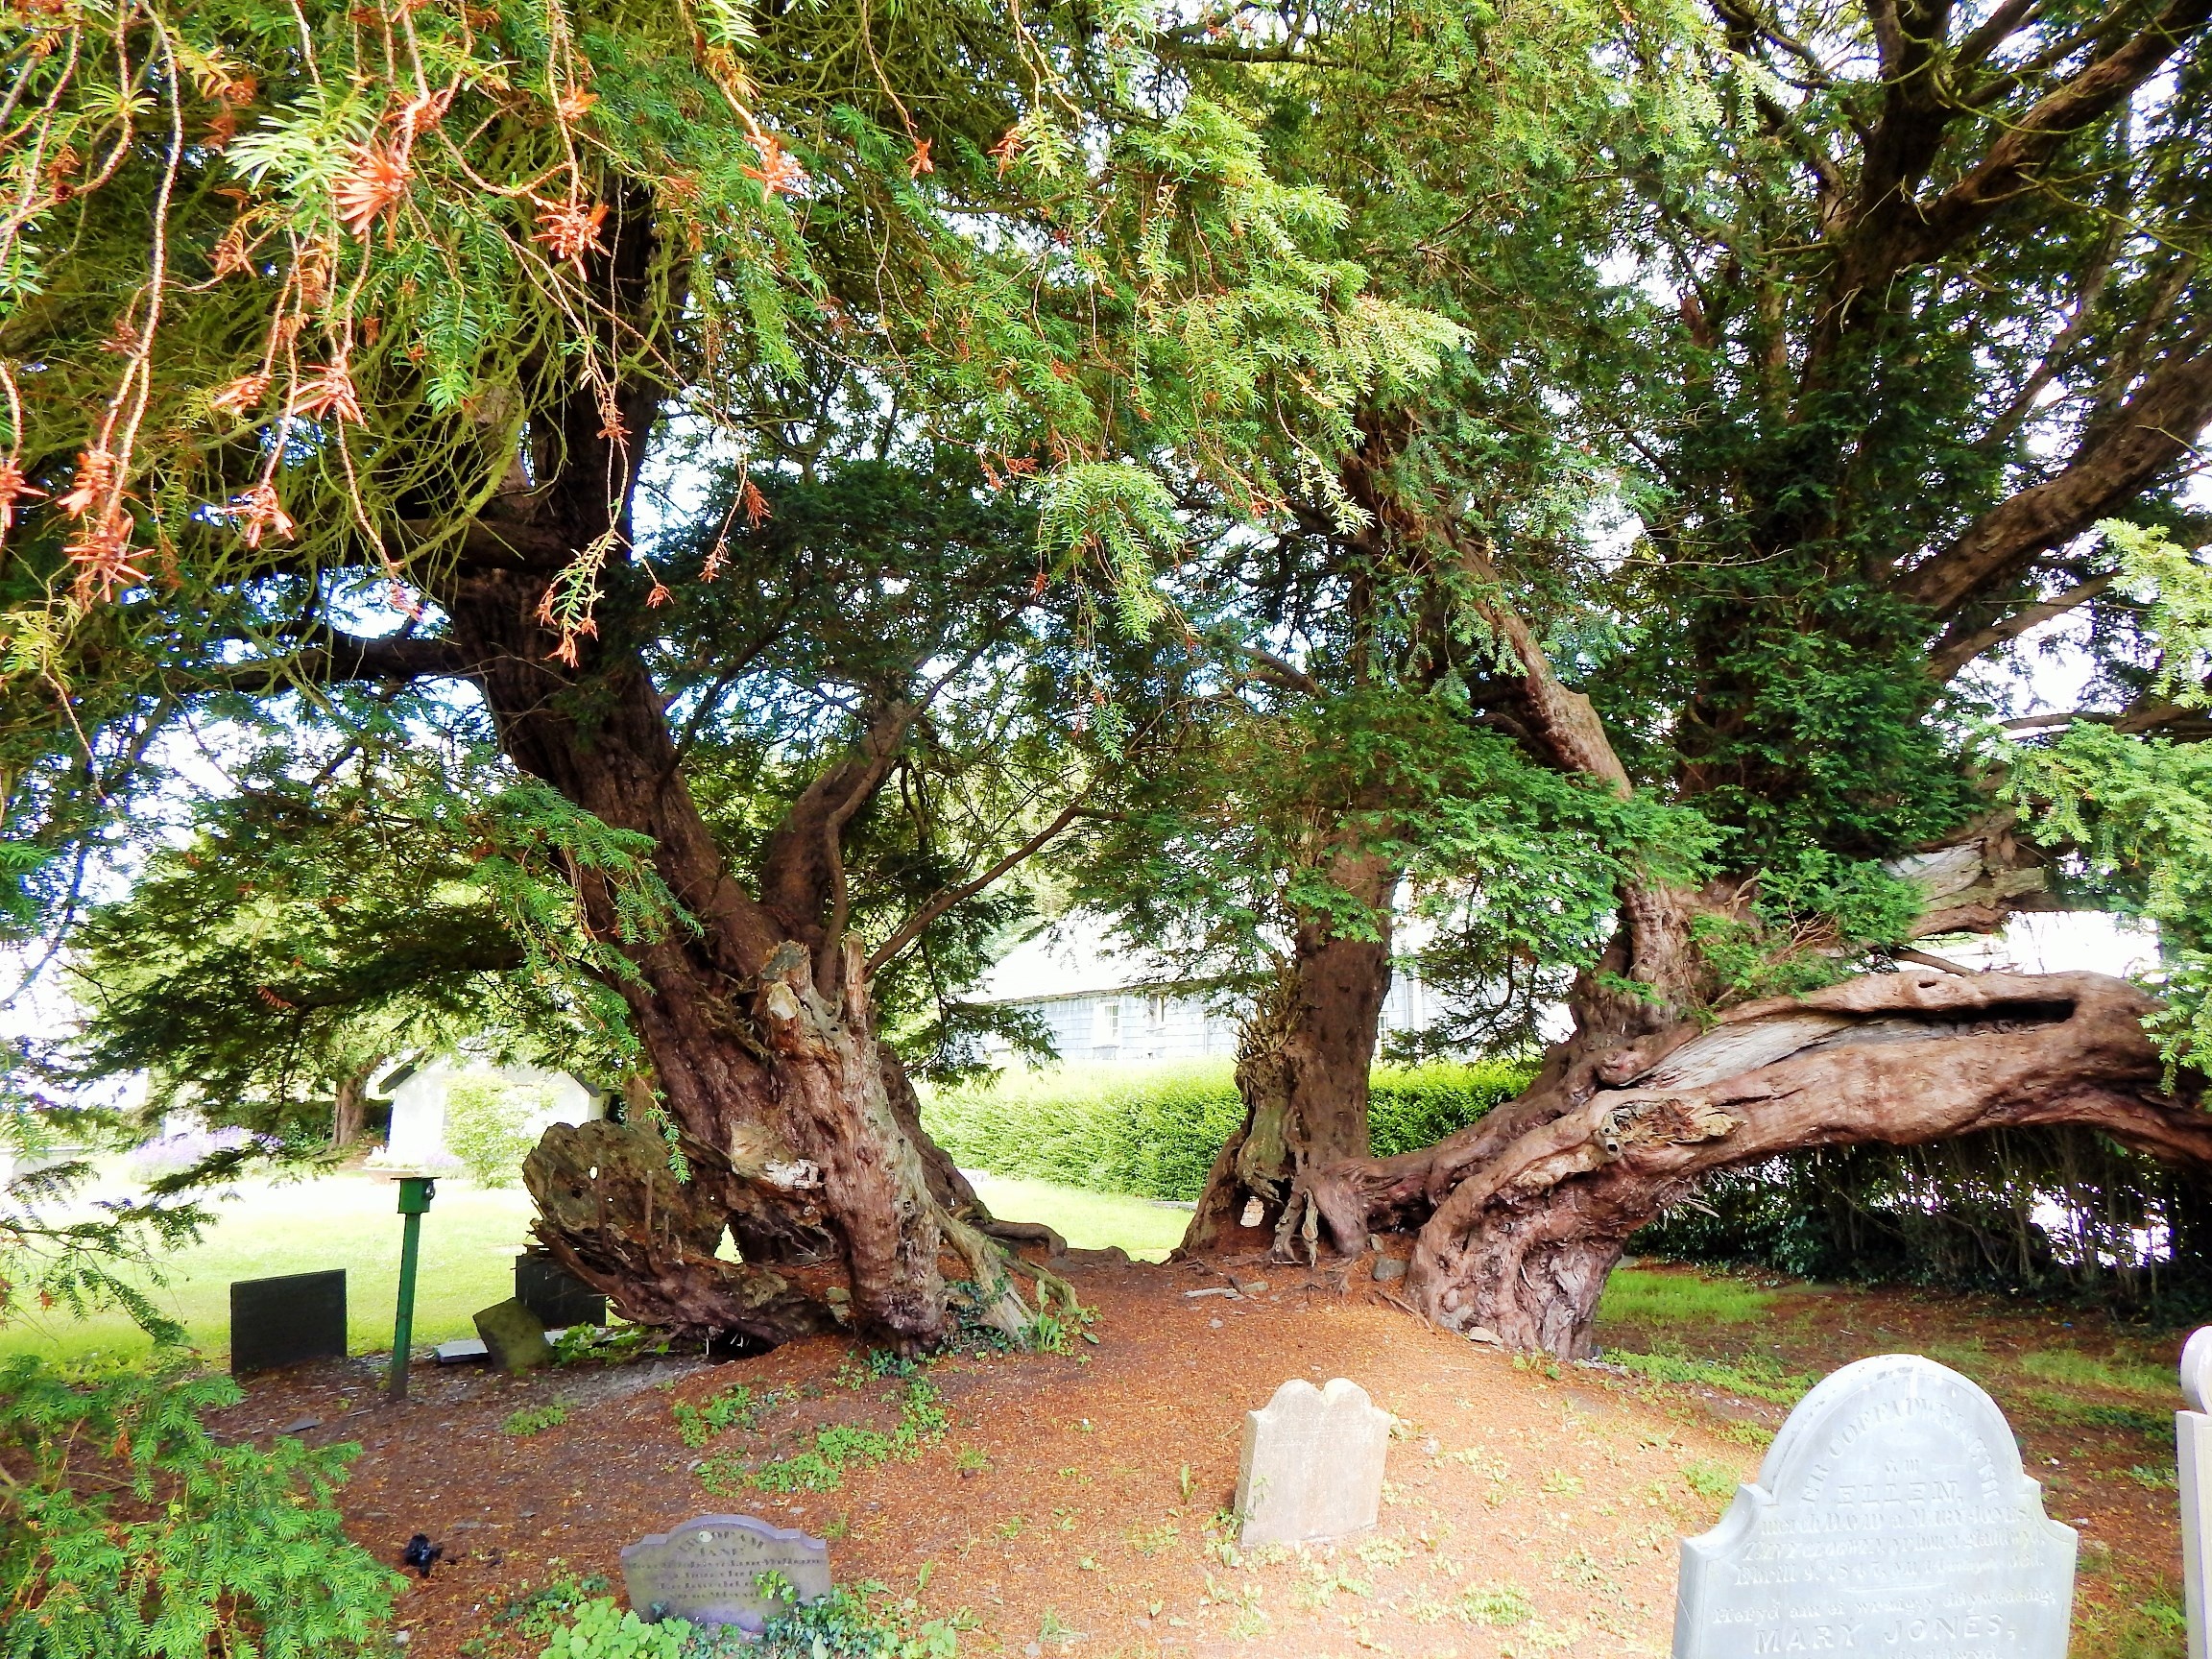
[203,1265,2178,1659]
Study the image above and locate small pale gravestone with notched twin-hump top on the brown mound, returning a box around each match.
[1237,1378,1389,1549]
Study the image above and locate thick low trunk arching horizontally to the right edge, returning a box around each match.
[1314,967,2212,1358]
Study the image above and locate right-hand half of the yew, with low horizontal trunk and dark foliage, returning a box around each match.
[1115,0,2212,1354]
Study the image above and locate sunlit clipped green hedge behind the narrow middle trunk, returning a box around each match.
[923,1060,1530,1201]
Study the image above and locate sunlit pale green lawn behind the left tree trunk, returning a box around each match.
[0,1174,1190,1358]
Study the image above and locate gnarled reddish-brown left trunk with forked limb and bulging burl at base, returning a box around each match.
[416,192,1057,1349]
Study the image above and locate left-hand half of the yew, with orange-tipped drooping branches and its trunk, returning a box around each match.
[0,0,1449,1345]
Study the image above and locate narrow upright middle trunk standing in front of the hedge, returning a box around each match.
[1181,850,1403,1261]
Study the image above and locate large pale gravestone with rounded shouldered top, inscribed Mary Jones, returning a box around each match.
[1674,1354,2075,1659]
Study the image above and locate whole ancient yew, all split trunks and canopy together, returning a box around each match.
[12,0,2212,1354]
